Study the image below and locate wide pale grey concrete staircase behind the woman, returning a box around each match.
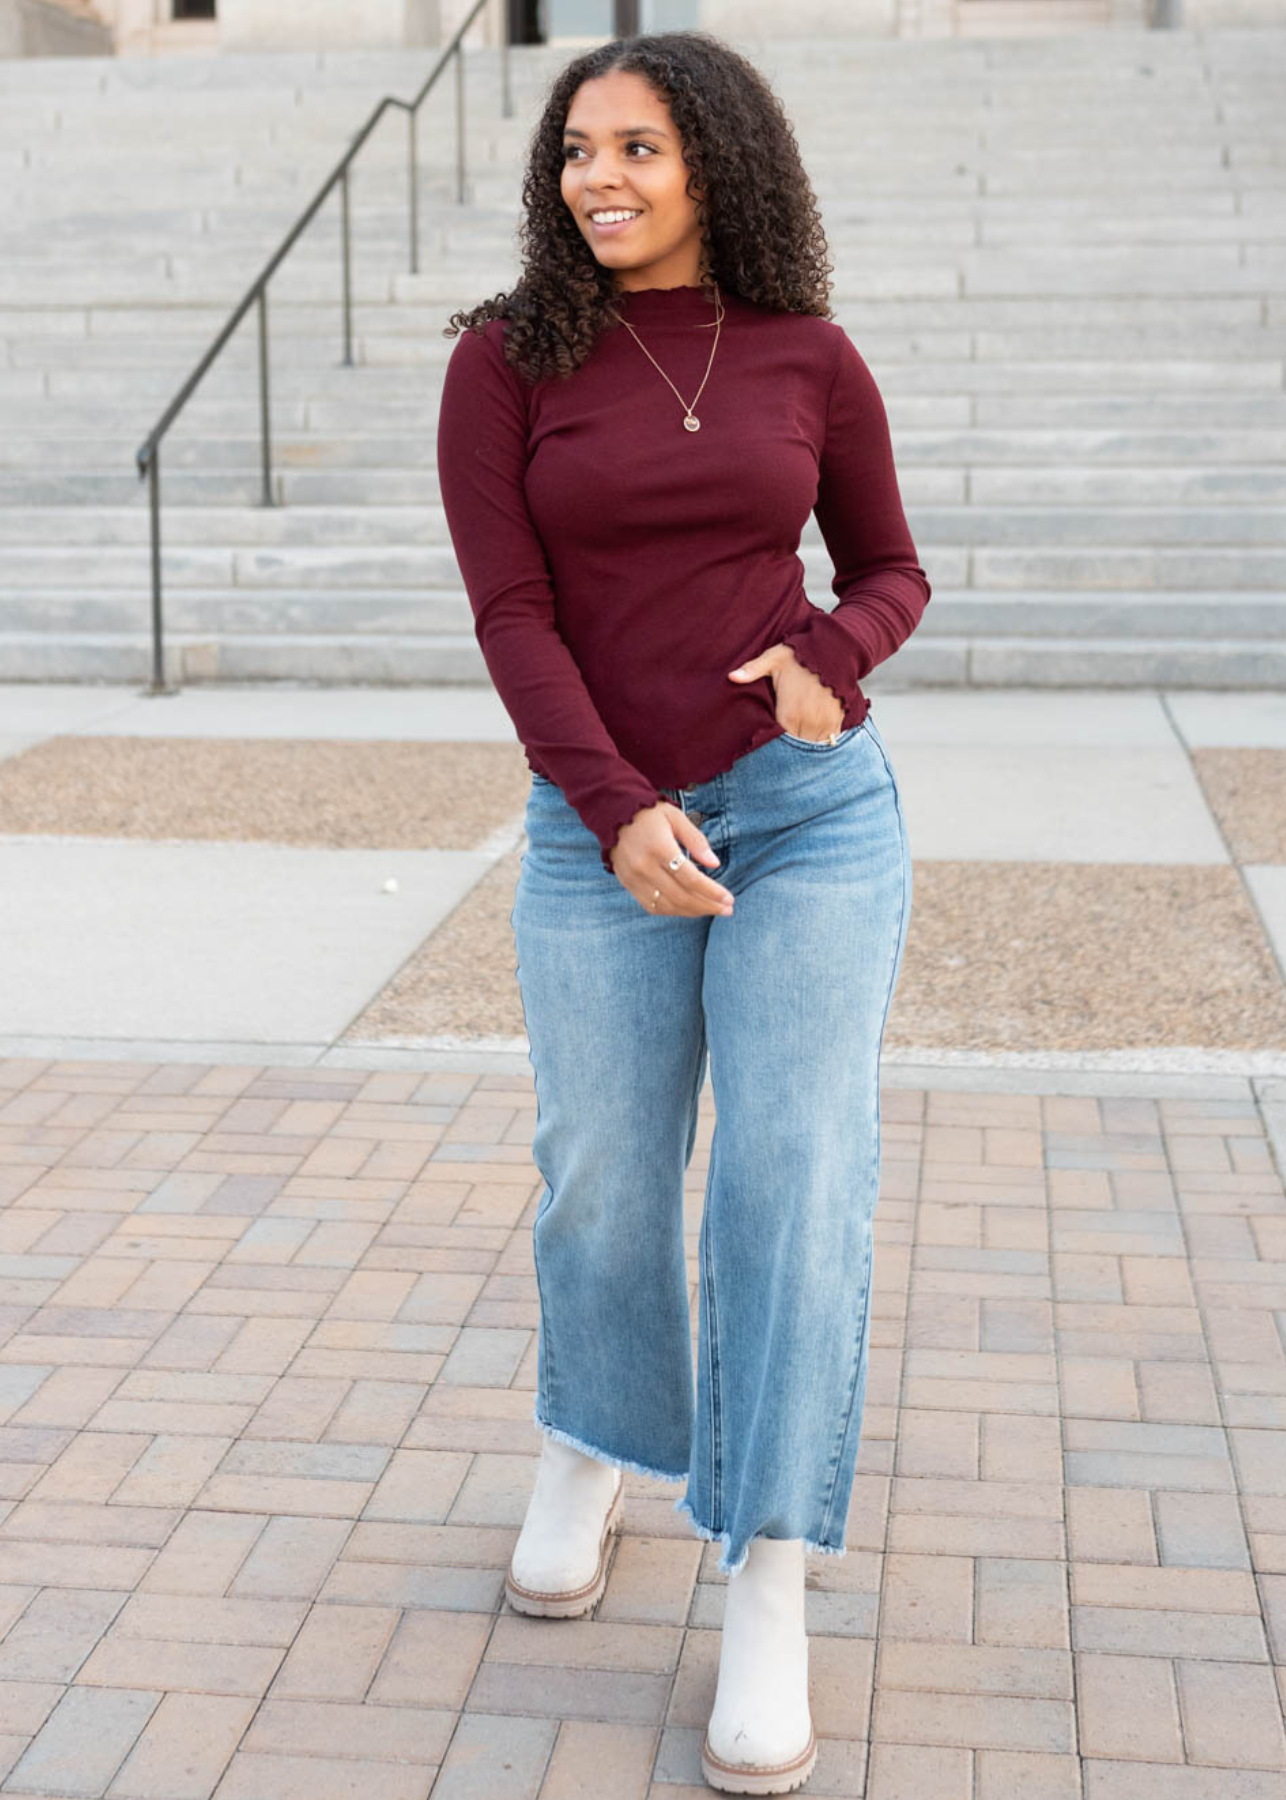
[0,31,1286,688]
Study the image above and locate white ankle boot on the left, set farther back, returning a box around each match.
[504,1431,625,1618]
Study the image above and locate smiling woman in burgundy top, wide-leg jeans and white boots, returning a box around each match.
[438,31,929,1795]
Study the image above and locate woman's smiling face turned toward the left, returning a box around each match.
[560,68,702,288]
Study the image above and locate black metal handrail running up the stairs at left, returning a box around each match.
[135,0,513,695]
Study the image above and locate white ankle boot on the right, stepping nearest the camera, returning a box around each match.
[701,1537,818,1795]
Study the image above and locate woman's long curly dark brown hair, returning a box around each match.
[443,31,832,382]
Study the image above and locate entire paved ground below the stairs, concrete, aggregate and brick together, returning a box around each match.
[0,686,1286,1800]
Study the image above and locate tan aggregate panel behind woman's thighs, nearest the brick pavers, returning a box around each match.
[346,851,1286,1051]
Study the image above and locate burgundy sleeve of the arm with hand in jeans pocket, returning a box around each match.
[770,328,931,711]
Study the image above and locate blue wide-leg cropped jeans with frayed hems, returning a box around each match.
[510,713,911,1573]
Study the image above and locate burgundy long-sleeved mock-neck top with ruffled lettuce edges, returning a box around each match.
[438,286,931,873]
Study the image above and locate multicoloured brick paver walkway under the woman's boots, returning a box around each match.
[0,1060,1286,1800]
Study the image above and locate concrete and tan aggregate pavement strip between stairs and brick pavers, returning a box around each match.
[0,686,1286,1075]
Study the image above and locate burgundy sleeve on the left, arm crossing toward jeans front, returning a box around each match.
[438,329,665,873]
